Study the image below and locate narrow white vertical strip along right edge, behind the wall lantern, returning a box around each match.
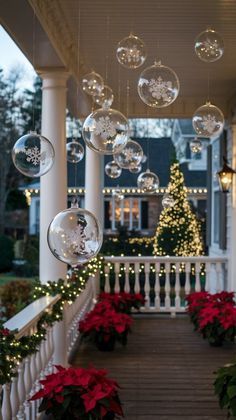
[227,123,236,292]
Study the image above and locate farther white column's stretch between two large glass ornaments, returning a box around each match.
[84,147,104,228]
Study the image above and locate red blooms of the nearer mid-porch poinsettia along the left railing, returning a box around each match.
[79,300,132,341]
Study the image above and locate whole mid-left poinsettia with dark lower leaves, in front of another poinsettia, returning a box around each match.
[79,301,132,351]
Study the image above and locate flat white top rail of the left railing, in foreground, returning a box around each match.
[4,295,60,338]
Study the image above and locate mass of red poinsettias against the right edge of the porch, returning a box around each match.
[187,292,236,343]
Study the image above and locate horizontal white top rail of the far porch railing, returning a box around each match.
[104,256,228,264]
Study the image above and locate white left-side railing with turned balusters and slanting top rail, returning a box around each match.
[0,278,96,420]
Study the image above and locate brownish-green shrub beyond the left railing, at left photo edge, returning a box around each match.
[0,280,33,319]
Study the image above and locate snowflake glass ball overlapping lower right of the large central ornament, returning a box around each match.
[114,140,143,169]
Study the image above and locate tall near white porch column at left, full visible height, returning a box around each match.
[40,70,68,283]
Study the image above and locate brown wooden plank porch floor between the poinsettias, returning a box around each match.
[73,315,235,420]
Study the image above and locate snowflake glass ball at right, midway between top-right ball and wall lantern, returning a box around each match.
[192,102,225,137]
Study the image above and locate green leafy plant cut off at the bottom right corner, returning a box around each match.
[214,363,236,417]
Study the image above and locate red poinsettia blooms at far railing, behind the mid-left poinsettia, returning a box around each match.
[98,292,145,313]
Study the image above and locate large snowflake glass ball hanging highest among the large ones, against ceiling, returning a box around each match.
[138,61,179,108]
